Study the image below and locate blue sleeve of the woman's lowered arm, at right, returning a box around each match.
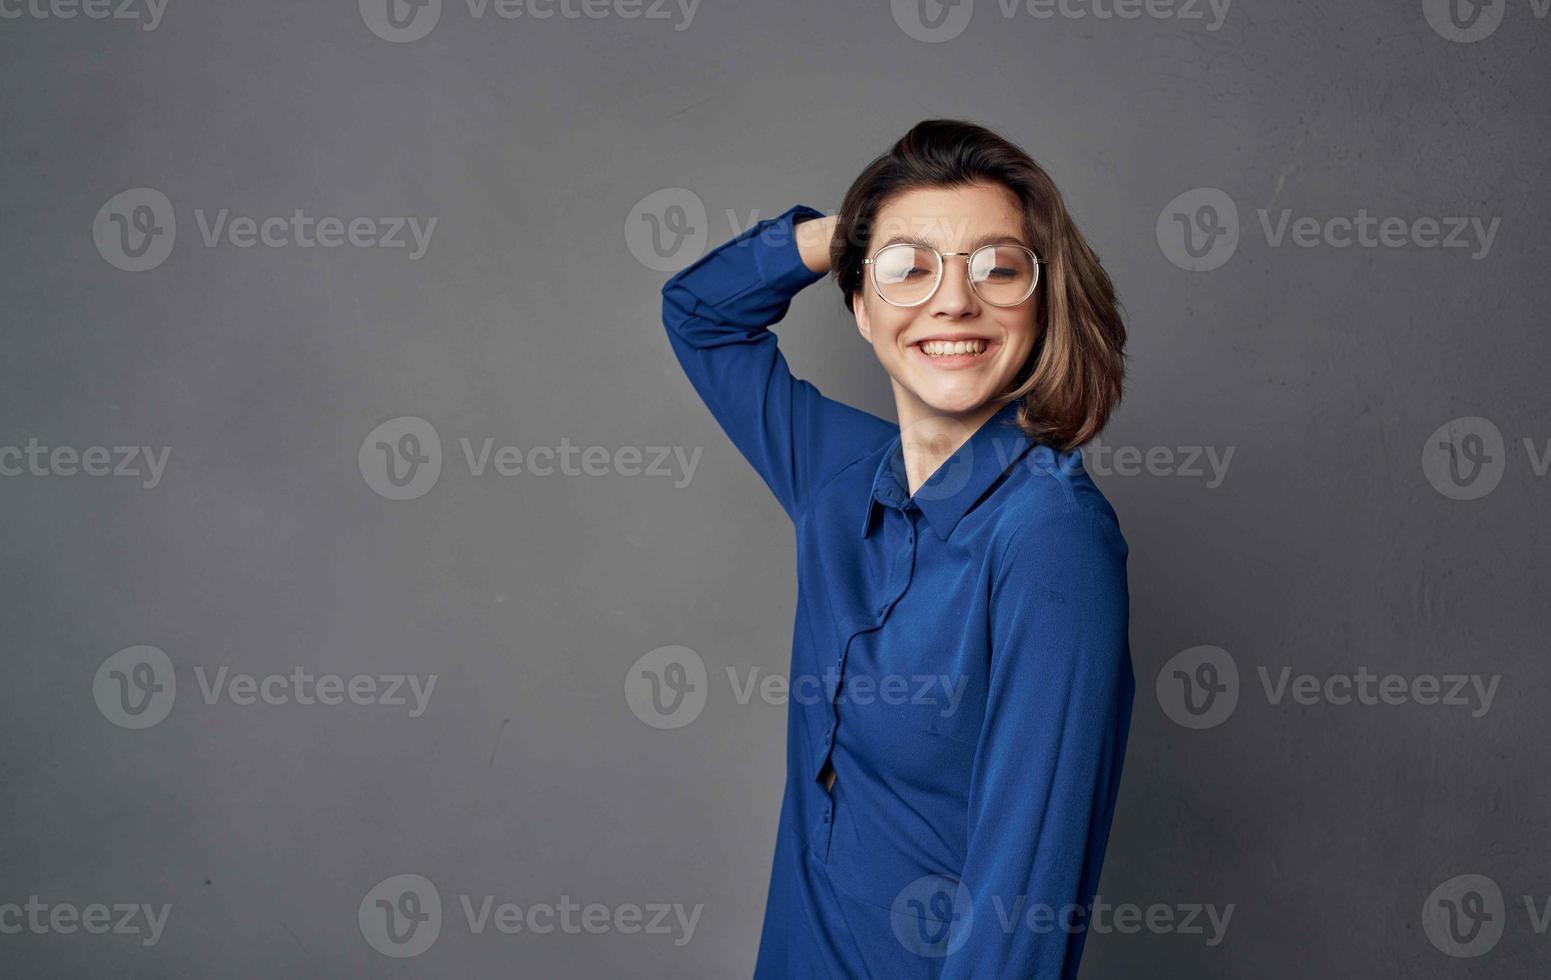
[941,506,1135,980]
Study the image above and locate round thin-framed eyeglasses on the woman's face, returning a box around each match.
[862,242,1044,307]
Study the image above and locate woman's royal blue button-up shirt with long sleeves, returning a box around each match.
[662,205,1135,980]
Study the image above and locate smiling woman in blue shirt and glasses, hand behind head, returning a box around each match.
[662,119,1135,980]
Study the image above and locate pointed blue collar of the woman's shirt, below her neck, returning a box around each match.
[861,400,1035,540]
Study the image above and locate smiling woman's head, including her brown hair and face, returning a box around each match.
[831,121,1126,462]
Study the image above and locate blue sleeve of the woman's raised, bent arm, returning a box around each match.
[662,205,895,521]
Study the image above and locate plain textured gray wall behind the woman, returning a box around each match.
[0,0,1551,980]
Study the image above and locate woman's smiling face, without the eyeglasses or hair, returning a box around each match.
[853,185,1041,425]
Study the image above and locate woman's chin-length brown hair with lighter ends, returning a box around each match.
[830,119,1126,451]
